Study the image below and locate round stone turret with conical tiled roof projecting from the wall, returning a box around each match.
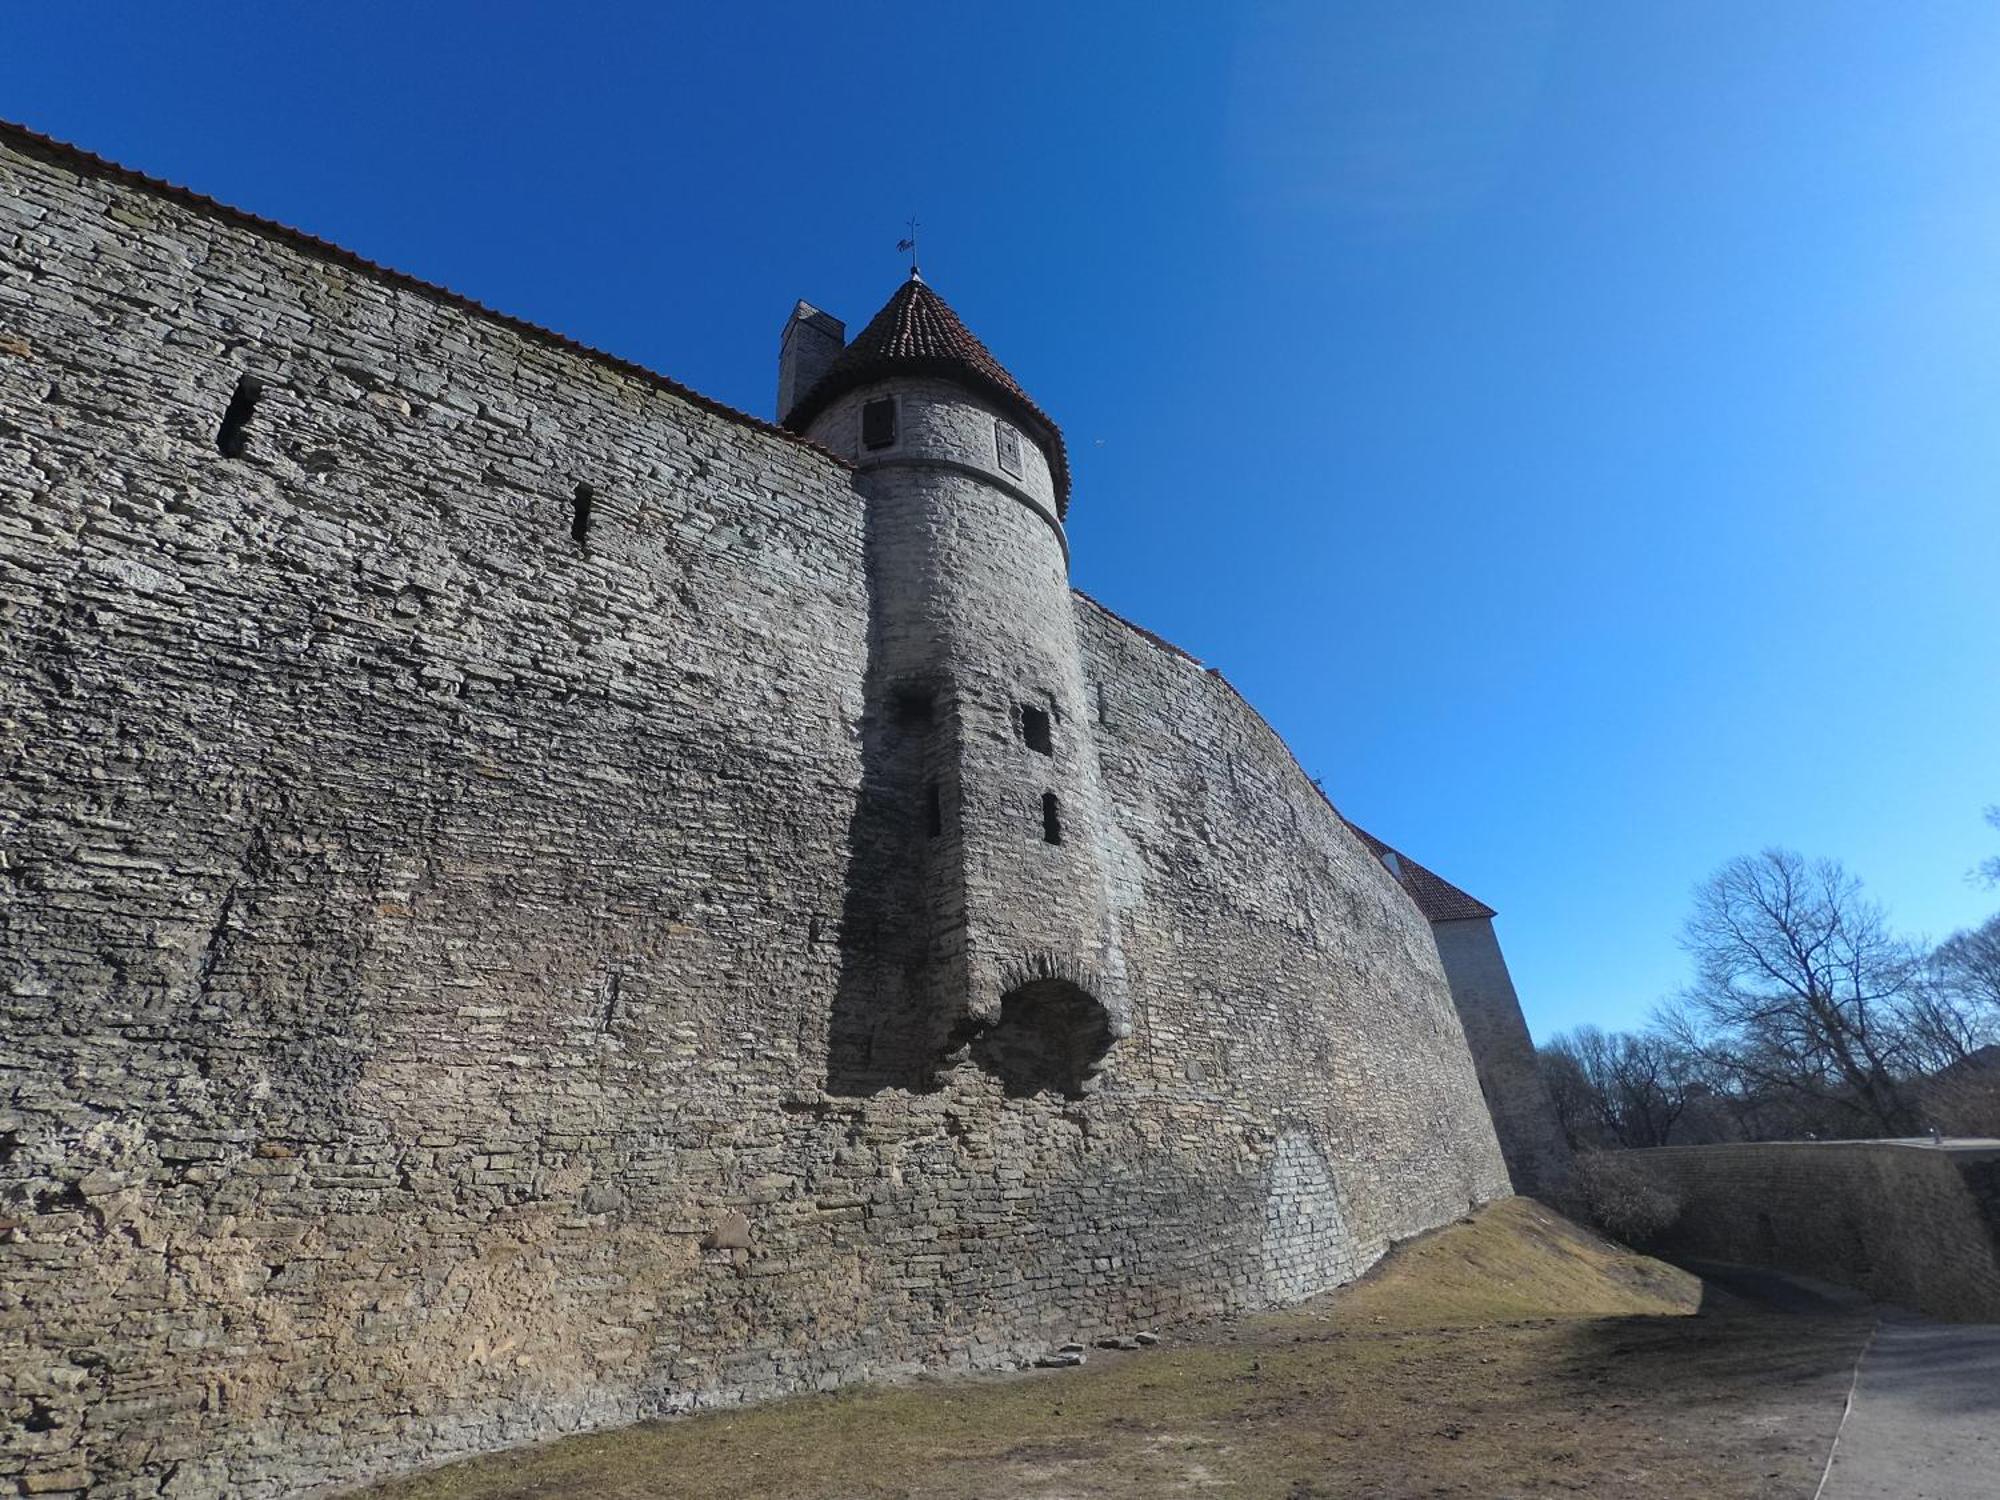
[784,270,1128,1094]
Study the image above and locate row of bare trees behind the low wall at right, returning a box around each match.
[1538,808,2000,1150]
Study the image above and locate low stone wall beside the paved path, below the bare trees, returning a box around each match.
[1622,1142,2000,1322]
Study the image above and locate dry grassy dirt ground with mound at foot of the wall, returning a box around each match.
[366,1198,1870,1500]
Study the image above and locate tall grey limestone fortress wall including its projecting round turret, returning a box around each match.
[0,128,1558,1496]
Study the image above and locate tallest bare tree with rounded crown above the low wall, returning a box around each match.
[1682,850,1920,1134]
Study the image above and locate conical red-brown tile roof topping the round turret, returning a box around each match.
[784,274,1070,514]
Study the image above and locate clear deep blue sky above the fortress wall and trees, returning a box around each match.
[0,0,2000,1036]
